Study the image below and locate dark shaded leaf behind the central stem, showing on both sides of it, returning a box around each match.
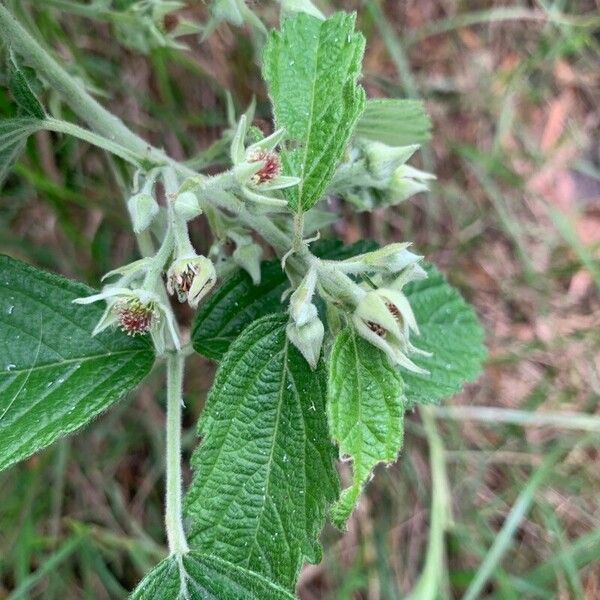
[192,240,376,360]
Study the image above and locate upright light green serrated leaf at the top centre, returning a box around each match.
[263,12,365,211]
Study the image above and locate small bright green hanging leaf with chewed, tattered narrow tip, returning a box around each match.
[327,327,406,527]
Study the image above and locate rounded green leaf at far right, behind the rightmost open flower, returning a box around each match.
[402,265,487,404]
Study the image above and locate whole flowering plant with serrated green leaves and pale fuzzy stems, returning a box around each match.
[0,0,485,600]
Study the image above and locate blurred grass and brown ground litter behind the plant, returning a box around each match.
[0,0,600,600]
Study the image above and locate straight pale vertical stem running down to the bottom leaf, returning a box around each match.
[165,353,189,555]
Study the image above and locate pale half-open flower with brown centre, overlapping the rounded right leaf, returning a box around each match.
[352,288,429,374]
